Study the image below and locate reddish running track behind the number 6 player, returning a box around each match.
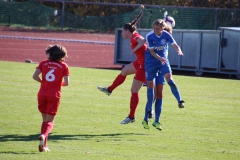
[0,27,122,69]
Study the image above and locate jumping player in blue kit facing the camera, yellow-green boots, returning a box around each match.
[142,19,184,130]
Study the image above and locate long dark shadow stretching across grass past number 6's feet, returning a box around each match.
[0,133,147,142]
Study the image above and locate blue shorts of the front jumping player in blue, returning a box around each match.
[145,61,172,81]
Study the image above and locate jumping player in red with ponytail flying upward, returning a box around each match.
[98,6,147,124]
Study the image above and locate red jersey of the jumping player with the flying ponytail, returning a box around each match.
[130,32,147,65]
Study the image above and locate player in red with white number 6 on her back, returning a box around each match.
[33,45,69,152]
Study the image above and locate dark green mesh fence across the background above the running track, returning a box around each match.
[0,0,240,32]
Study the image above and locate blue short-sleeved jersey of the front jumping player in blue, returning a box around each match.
[145,30,176,62]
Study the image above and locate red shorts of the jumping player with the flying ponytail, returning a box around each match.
[132,60,146,83]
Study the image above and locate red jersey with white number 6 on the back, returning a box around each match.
[36,60,69,98]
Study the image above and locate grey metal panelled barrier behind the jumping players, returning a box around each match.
[114,27,240,79]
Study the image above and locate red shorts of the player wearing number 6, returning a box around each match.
[38,94,60,115]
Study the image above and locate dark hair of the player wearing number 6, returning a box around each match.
[46,44,67,61]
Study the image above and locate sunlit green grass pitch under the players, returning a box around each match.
[0,61,240,160]
